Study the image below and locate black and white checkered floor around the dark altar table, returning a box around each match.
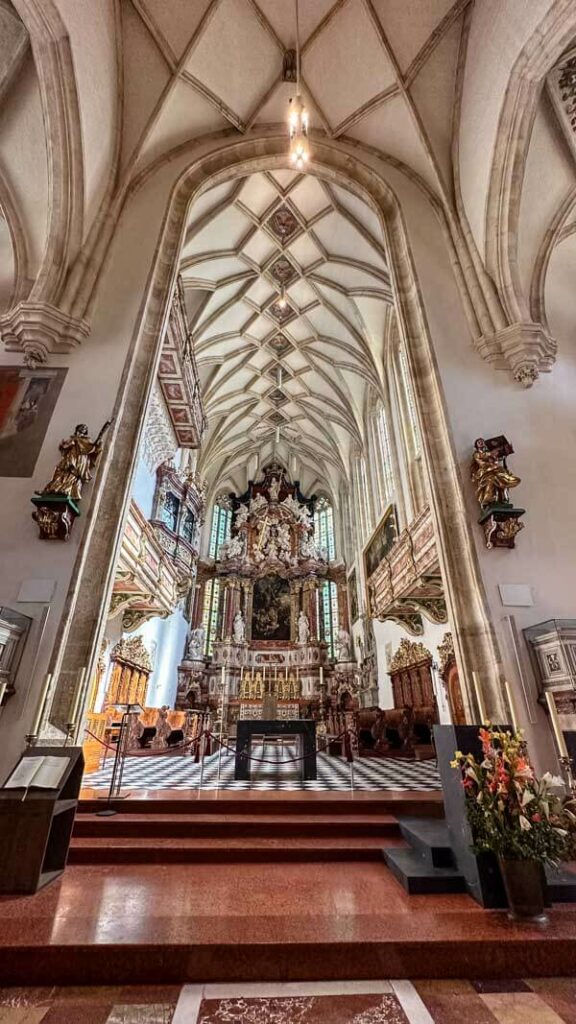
[84,743,441,791]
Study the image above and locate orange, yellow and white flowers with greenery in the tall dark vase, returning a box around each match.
[451,723,576,864]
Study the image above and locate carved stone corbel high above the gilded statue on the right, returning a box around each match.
[477,323,558,388]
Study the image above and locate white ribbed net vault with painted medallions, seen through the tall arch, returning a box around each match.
[186,170,394,497]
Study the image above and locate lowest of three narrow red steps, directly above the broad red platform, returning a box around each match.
[69,836,403,864]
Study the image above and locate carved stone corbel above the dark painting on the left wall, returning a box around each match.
[0,301,90,367]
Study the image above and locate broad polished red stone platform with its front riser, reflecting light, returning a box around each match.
[0,862,576,983]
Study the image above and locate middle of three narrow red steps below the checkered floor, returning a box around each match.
[74,813,400,839]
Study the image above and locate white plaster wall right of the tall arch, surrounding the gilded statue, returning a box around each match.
[393,167,576,765]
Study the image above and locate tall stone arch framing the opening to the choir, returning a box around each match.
[48,133,503,724]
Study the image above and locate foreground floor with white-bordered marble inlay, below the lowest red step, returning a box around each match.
[0,978,576,1024]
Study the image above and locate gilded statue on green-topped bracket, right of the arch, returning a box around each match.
[470,435,526,548]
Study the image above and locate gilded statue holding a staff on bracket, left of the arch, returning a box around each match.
[31,420,112,541]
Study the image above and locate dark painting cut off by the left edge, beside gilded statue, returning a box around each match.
[0,367,67,476]
